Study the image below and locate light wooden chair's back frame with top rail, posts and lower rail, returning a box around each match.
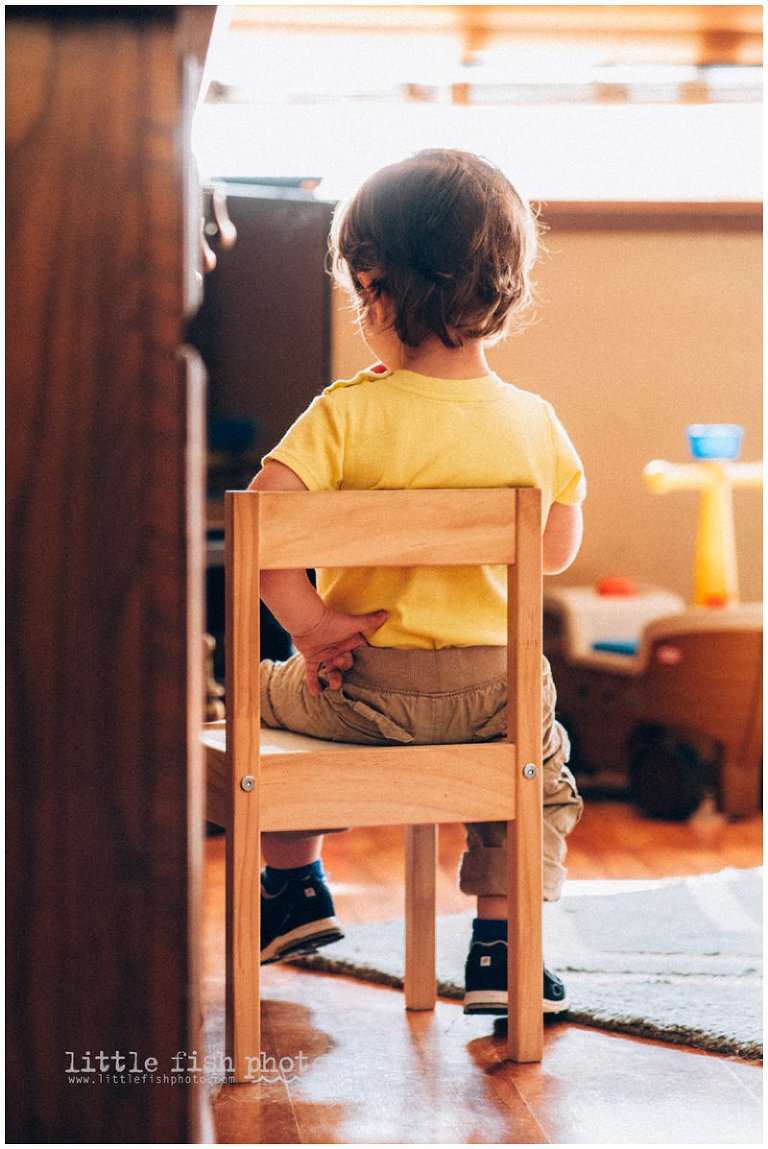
[226,488,542,830]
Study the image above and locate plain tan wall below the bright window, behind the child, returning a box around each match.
[333,215,762,600]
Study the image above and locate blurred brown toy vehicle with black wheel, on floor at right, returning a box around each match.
[544,587,762,820]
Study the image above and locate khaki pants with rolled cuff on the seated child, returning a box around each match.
[261,647,583,902]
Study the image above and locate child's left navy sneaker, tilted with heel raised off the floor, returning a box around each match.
[261,874,344,965]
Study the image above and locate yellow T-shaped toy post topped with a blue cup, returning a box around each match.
[644,423,762,607]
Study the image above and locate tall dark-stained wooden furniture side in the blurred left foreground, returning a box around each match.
[6,6,214,1144]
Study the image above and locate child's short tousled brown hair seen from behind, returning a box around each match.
[330,148,538,347]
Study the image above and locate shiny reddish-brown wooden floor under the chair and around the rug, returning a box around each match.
[205,801,762,1144]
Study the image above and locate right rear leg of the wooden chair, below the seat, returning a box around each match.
[507,813,544,1062]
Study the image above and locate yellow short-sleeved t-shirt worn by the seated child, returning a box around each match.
[264,370,586,649]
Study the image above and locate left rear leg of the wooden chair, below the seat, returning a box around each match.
[225,795,261,1082]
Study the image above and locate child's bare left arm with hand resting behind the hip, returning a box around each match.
[248,460,386,695]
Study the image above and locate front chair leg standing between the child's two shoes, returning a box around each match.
[405,825,437,1010]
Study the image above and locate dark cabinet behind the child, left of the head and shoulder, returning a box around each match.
[189,184,332,496]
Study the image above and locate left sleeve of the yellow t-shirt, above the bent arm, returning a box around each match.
[262,392,344,491]
